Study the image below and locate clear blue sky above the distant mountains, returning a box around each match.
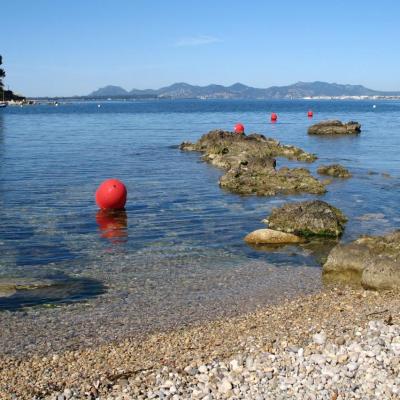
[0,0,400,96]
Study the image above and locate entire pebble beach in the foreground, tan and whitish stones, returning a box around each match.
[0,287,400,400]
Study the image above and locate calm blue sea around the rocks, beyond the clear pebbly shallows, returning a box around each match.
[0,101,400,308]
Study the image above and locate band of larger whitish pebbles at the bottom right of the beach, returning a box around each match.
[48,321,400,400]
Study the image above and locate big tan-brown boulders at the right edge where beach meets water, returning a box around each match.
[323,230,400,290]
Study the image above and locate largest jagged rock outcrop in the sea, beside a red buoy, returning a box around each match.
[180,130,326,196]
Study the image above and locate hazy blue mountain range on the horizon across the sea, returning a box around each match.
[86,81,400,99]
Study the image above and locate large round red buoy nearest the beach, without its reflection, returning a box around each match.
[95,179,127,210]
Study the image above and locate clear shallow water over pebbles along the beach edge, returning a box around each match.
[0,257,322,358]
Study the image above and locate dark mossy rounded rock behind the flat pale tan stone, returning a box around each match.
[265,200,347,237]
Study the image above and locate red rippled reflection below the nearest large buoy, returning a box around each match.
[96,210,128,243]
